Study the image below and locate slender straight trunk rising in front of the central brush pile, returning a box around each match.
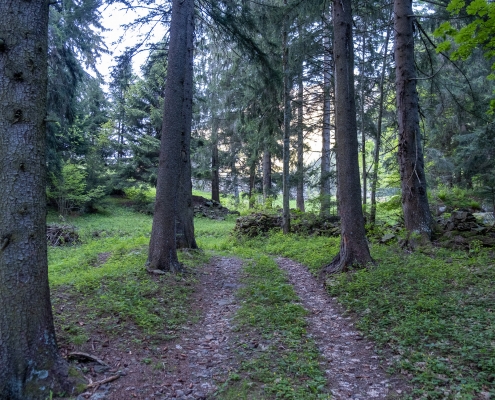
[282,0,291,234]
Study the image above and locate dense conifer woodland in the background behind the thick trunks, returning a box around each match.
[42,1,495,222]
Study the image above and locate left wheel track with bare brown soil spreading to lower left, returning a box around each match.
[77,258,246,400]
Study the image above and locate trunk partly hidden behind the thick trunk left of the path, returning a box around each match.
[176,5,198,249]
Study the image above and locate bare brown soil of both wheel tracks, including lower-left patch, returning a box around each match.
[68,258,408,400]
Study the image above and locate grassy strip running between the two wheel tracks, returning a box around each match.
[218,255,330,400]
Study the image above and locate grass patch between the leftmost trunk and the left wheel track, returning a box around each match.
[48,207,208,345]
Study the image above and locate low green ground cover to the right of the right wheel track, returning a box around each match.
[327,246,495,399]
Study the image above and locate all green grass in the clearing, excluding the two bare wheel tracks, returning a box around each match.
[49,202,495,399]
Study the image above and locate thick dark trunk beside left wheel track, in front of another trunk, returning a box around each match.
[147,0,194,272]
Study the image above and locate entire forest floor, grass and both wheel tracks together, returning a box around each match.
[48,204,495,400]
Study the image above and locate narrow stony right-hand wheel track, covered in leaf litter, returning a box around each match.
[277,258,406,400]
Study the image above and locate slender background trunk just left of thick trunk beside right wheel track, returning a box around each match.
[320,35,332,217]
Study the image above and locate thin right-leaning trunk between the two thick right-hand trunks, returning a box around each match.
[370,23,390,225]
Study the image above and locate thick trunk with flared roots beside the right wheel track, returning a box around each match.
[324,0,372,273]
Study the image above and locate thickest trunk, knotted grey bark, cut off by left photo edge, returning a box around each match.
[0,0,82,400]
